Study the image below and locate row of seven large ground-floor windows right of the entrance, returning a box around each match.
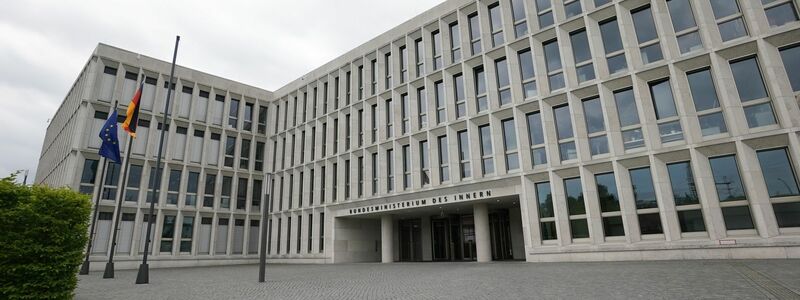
[535,148,800,241]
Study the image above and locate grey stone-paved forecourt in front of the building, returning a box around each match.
[75,260,800,299]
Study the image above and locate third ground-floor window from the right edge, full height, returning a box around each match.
[667,162,706,232]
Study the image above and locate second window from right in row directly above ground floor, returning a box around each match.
[731,57,777,128]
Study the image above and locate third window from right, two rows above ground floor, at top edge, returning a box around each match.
[667,0,703,53]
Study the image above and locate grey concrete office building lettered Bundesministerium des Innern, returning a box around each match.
[36,0,800,267]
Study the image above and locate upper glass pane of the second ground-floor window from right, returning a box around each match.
[708,155,747,202]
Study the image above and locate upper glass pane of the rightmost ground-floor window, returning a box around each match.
[758,148,800,198]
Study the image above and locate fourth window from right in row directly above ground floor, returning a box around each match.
[648,79,683,143]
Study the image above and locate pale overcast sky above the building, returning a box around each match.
[0,0,442,182]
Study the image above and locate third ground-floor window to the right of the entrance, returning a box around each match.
[594,173,625,236]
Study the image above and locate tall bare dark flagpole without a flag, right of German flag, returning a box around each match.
[136,36,181,284]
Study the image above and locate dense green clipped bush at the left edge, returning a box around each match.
[0,175,91,299]
